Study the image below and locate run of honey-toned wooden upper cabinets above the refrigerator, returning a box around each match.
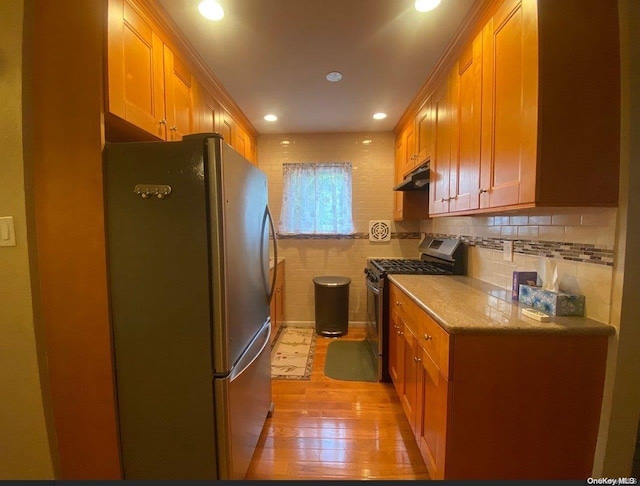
[105,0,256,147]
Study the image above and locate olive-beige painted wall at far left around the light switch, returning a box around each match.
[0,0,54,479]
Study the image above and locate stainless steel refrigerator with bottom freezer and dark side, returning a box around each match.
[104,134,277,479]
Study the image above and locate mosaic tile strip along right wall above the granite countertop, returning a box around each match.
[428,233,613,267]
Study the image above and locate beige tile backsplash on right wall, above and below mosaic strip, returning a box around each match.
[420,208,617,323]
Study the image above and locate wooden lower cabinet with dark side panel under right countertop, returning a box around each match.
[389,283,608,480]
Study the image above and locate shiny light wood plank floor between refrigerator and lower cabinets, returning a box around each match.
[247,328,429,480]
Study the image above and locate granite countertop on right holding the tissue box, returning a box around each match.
[388,274,615,335]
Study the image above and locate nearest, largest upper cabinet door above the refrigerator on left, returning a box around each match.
[107,0,167,140]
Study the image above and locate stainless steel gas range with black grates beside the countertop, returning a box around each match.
[364,236,467,381]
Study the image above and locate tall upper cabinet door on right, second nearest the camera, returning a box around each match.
[449,35,482,212]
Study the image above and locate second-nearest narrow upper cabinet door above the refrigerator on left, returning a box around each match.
[164,46,195,140]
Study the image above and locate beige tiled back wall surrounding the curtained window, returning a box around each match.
[258,133,419,326]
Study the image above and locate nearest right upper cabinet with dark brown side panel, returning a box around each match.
[480,0,620,209]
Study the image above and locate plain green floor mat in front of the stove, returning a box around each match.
[324,340,378,381]
